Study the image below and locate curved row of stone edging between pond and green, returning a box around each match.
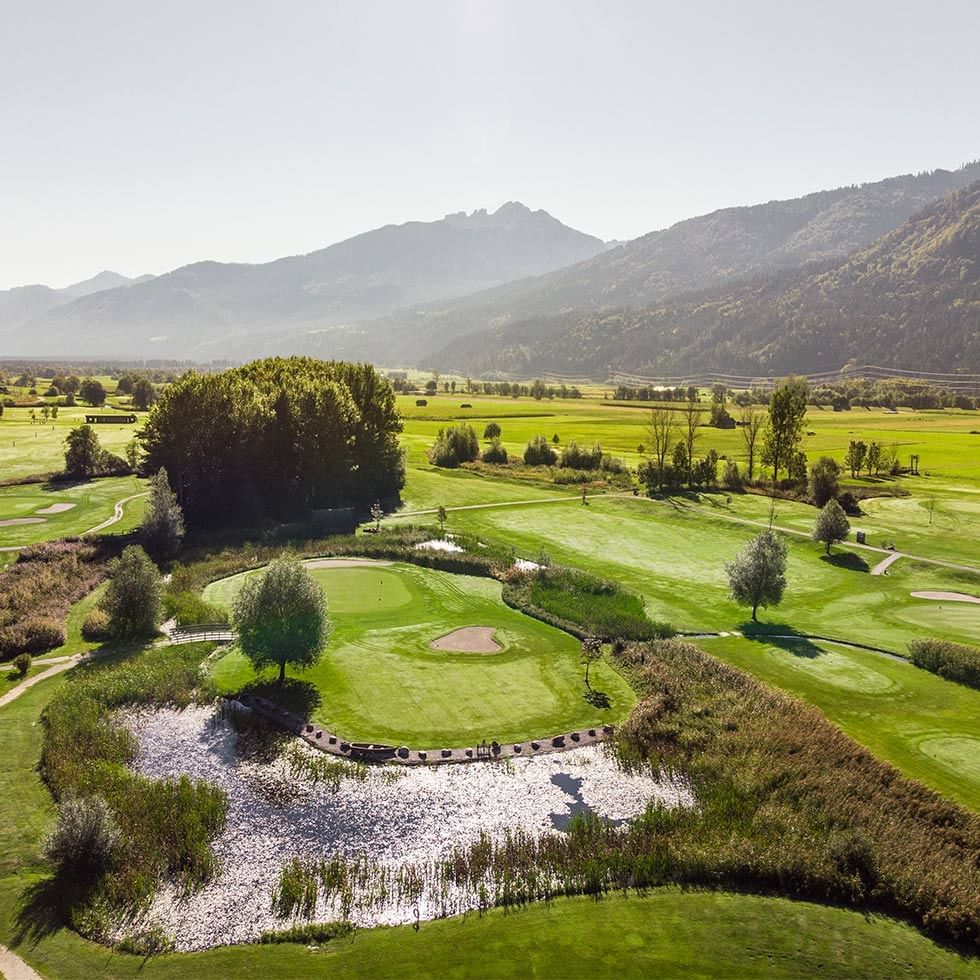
[232,695,614,766]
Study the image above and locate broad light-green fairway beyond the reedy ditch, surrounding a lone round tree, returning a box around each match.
[414,497,980,653]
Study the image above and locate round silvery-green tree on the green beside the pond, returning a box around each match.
[233,558,330,684]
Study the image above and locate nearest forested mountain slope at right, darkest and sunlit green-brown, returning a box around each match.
[425,181,980,377]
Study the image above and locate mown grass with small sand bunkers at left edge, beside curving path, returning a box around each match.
[0,476,146,547]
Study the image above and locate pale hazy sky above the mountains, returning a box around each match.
[0,0,980,288]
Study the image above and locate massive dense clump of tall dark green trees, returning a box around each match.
[139,357,405,527]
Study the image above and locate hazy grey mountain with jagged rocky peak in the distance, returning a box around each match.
[0,202,605,357]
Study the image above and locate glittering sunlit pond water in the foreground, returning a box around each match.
[124,707,693,950]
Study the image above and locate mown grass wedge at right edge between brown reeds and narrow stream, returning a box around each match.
[699,638,980,811]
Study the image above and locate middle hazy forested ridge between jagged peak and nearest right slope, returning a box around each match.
[344,162,980,363]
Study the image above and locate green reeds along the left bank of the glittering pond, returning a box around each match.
[40,644,227,938]
